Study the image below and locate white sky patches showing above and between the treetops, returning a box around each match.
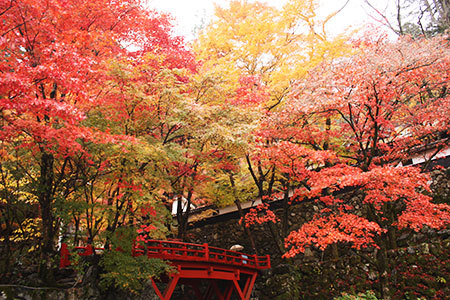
[147,0,370,40]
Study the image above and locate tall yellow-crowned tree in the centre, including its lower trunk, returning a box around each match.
[194,0,351,253]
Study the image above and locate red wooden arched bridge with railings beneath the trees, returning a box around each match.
[60,240,270,300]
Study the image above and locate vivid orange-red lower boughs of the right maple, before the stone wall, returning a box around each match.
[285,166,450,257]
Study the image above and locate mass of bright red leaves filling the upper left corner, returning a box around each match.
[0,0,195,156]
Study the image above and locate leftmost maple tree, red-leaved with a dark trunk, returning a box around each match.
[0,0,195,280]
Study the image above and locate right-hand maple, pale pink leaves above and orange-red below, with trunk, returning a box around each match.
[261,37,450,298]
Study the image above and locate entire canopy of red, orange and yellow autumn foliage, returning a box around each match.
[0,0,450,292]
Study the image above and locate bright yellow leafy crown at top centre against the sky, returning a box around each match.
[194,0,350,107]
